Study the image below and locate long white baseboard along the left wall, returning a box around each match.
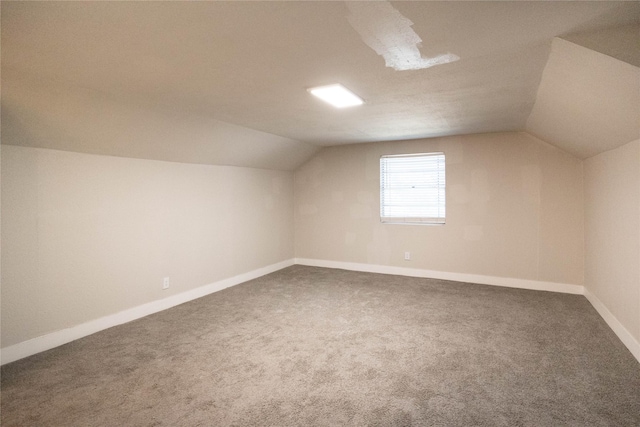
[0,259,294,365]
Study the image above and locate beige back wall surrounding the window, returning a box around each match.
[294,132,584,285]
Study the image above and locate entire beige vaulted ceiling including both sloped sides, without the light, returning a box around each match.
[1,1,640,170]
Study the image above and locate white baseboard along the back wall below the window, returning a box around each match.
[296,258,584,295]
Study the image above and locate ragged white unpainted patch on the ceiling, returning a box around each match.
[346,1,460,71]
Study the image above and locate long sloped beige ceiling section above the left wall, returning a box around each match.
[2,77,318,171]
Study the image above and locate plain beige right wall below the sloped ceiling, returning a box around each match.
[585,140,640,342]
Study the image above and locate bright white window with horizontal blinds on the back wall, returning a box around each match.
[380,153,445,224]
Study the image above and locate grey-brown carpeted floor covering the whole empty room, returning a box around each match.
[1,266,640,427]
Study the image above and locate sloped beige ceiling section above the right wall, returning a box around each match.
[525,38,640,159]
